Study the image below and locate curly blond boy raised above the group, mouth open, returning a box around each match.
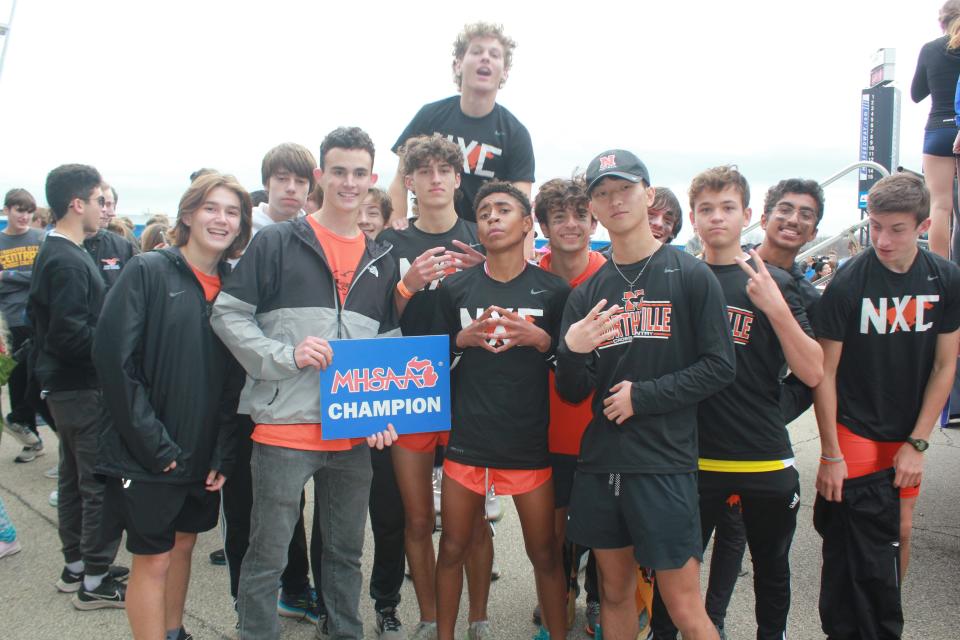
[389,22,534,228]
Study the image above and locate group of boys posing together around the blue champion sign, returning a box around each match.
[0,17,960,640]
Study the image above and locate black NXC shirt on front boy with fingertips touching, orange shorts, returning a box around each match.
[438,264,570,469]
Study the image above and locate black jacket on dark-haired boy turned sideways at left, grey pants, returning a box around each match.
[27,232,104,391]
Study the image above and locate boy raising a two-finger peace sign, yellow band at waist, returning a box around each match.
[653,166,823,640]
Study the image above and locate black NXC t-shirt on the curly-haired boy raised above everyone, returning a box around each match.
[393,96,534,222]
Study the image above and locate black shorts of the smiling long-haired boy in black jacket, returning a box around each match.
[103,478,220,555]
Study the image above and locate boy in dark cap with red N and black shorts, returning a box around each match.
[557,149,735,640]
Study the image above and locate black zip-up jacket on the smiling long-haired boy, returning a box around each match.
[93,248,244,484]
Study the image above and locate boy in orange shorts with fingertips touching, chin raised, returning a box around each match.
[437,182,570,640]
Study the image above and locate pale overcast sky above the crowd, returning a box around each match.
[0,0,942,242]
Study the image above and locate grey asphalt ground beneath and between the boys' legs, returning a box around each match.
[0,412,960,640]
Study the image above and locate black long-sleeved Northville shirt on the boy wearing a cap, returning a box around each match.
[557,247,735,473]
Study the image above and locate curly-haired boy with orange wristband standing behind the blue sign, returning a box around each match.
[374,136,493,640]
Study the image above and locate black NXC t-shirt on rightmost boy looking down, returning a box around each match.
[814,247,960,442]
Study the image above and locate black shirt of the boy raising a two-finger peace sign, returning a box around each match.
[697,260,813,471]
